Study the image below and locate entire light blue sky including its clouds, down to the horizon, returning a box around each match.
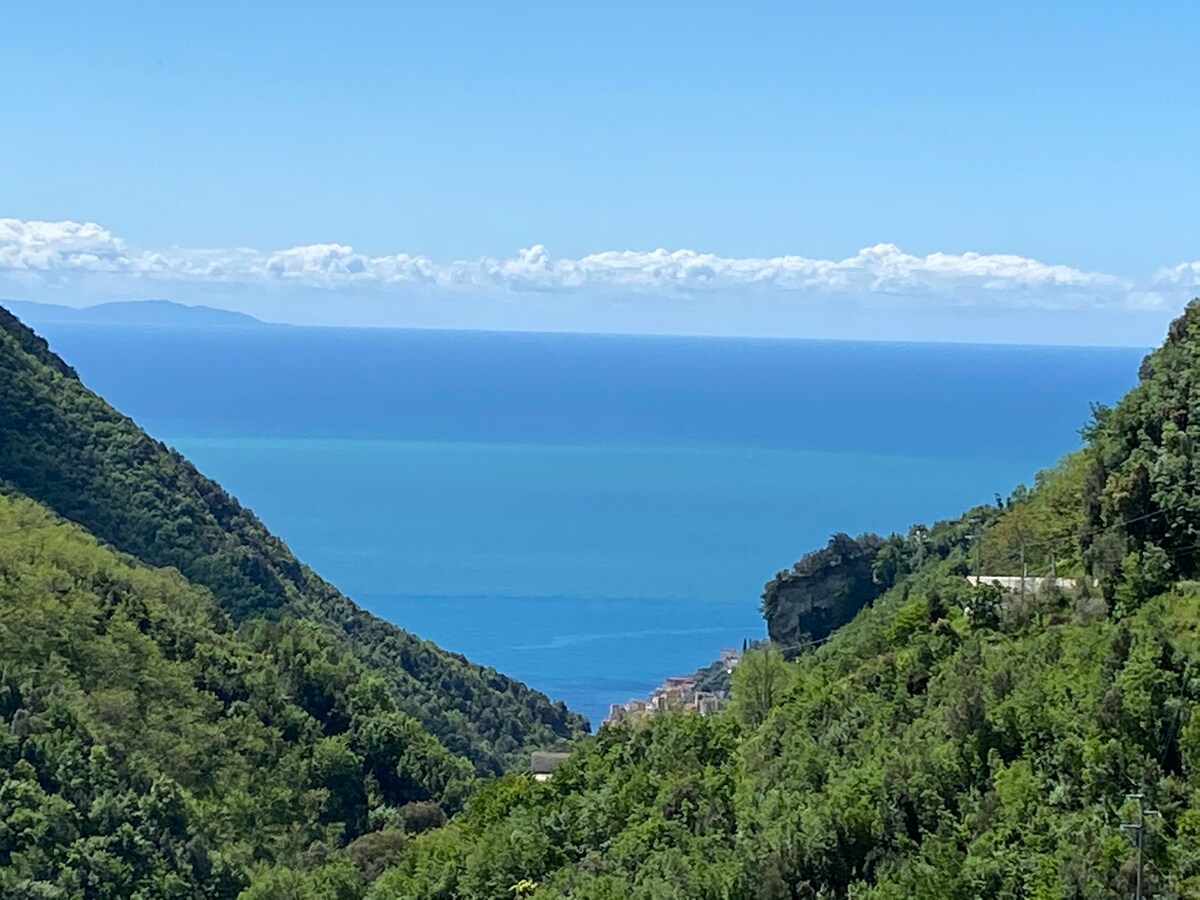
[0,0,1200,342]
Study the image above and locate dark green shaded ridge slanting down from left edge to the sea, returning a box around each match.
[0,308,586,772]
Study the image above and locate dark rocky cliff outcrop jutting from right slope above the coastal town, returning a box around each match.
[762,534,883,656]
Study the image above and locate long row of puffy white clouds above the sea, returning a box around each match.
[0,218,1180,310]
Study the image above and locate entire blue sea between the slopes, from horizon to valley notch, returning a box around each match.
[41,325,1142,722]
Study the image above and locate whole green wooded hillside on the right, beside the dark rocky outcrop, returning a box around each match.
[362,301,1200,900]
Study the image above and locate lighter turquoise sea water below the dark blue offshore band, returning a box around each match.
[168,436,1051,716]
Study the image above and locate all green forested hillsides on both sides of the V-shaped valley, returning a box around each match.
[7,301,1200,900]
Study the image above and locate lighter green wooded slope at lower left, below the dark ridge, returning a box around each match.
[0,496,473,898]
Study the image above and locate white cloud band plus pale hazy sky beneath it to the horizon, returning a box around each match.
[0,218,1200,343]
